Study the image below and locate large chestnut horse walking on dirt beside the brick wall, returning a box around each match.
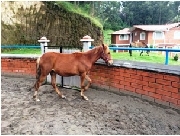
[33,44,113,101]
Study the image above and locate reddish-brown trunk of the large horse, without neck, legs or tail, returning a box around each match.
[40,52,85,76]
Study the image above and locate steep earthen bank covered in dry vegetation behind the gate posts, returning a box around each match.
[1,1,103,47]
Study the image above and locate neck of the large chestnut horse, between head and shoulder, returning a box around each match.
[86,47,101,63]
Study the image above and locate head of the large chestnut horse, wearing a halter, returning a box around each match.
[101,44,113,66]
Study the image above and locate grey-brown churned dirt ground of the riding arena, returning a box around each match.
[1,76,180,135]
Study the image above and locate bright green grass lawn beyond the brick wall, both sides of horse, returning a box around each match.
[2,48,180,65]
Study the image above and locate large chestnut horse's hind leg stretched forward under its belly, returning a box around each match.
[50,71,66,98]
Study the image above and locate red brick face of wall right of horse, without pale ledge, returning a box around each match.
[90,65,180,108]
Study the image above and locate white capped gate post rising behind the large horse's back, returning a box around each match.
[80,35,94,52]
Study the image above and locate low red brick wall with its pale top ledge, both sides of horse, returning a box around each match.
[1,55,180,110]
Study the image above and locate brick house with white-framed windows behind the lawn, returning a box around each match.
[111,22,180,55]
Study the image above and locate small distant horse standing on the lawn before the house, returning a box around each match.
[129,41,150,56]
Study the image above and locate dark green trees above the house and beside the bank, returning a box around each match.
[67,1,180,30]
